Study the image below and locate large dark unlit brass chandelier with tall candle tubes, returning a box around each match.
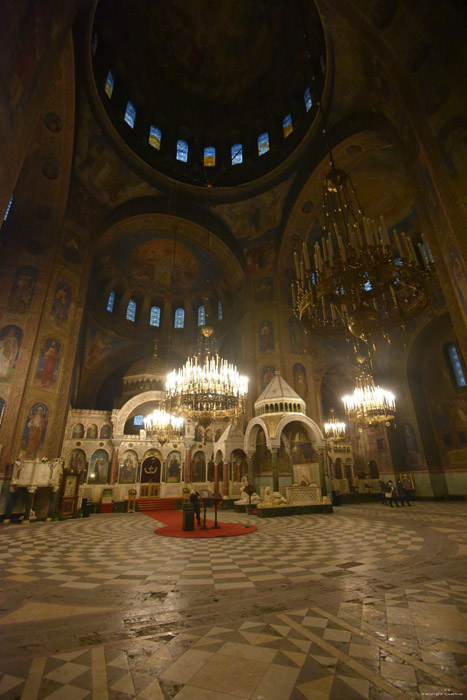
[292,157,434,341]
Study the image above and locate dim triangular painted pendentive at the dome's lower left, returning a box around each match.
[75,107,159,207]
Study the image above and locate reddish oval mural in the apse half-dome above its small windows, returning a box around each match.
[113,231,219,291]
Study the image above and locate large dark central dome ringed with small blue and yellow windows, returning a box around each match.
[92,0,325,186]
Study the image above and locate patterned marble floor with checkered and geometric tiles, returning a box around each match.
[0,502,467,700]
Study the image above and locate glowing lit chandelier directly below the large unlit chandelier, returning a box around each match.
[342,366,396,426]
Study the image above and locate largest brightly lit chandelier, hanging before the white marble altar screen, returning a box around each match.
[166,326,248,426]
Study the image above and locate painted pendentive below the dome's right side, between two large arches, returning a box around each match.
[212,178,292,245]
